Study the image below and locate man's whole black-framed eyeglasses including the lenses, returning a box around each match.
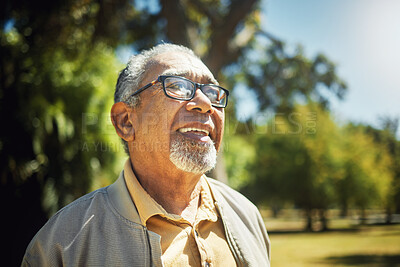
[131,75,229,108]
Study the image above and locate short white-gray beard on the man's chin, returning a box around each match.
[169,136,217,174]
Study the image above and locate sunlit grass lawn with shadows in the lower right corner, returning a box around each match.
[266,210,400,267]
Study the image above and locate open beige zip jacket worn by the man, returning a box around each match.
[22,172,270,267]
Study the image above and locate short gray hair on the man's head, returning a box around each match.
[114,43,198,155]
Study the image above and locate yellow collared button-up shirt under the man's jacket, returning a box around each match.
[124,160,236,266]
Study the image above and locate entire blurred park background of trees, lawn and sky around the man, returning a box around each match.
[0,0,400,266]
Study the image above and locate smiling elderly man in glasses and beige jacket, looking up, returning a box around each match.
[23,44,270,266]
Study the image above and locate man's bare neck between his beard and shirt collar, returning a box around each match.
[131,157,201,223]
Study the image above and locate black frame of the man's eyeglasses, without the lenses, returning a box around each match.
[130,75,229,108]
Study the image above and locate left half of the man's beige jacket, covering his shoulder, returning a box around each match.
[23,180,157,266]
